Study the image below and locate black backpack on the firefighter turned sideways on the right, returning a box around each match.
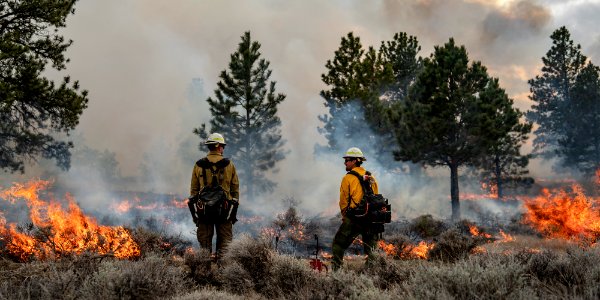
[346,171,392,233]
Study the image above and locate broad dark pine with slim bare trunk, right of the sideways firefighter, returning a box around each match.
[394,39,519,221]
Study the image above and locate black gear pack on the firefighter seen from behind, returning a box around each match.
[188,158,238,224]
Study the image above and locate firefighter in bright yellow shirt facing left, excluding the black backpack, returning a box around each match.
[332,147,378,270]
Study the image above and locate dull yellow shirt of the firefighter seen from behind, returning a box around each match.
[190,151,240,201]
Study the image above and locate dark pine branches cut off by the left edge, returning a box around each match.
[0,0,88,172]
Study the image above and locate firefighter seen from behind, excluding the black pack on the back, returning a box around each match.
[190,133,240,261]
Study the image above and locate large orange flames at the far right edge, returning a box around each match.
[523,184,600,240]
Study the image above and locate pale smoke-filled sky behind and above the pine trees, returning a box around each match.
[30,0,600,216]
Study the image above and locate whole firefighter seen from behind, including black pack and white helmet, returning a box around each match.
[188,133,240,260]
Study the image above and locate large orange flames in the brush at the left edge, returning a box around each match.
[0,180,140,261]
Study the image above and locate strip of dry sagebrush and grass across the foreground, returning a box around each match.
[0,224,600,299]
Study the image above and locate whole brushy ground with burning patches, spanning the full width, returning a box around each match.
[0,177,600,299]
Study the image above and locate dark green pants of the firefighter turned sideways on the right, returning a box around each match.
[331,217,376,270]
